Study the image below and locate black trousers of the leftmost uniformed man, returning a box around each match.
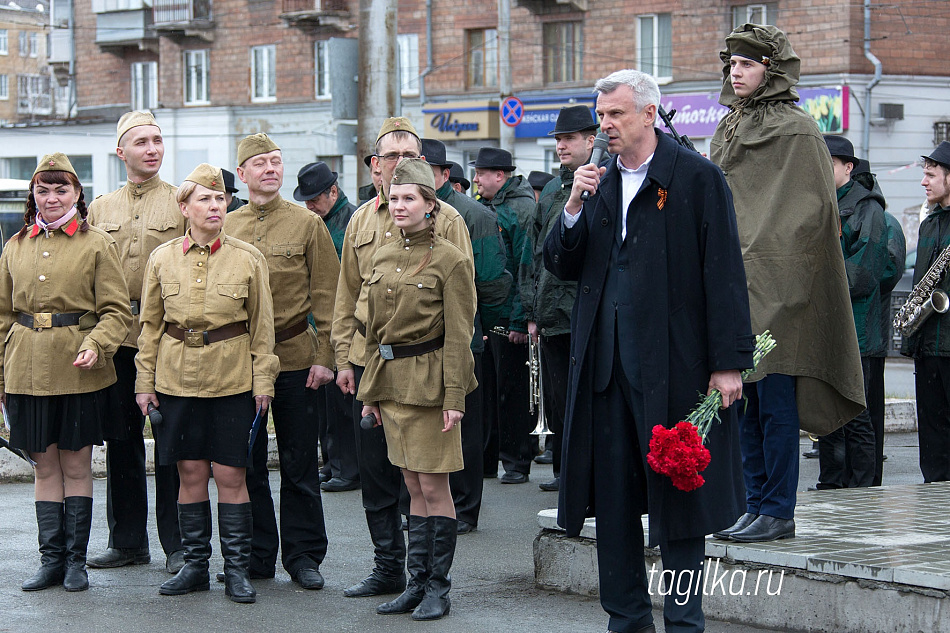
[106,347,182,555]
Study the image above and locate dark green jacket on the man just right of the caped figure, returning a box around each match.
[838,180,889,356]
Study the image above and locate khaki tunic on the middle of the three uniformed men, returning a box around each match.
[224,196,340,371]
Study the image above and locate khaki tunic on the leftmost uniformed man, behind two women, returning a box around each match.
[89,176,187,347]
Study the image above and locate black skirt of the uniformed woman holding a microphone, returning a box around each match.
[152,391,258,468]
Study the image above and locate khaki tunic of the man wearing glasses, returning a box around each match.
[333,191,473,369]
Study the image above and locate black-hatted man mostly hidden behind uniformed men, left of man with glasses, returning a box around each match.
[294,162,360,492]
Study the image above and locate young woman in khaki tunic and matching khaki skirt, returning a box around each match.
[357,159,477,620]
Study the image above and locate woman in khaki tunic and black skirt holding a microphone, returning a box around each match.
[135,163,280,602]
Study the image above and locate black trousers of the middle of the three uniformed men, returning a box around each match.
[247,369,327,576]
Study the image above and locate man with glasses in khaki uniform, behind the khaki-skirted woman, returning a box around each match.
[333,117,472,598]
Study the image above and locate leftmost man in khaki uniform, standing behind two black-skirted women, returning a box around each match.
[87,112,186,573]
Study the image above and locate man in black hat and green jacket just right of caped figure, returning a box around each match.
[817,136,890,490]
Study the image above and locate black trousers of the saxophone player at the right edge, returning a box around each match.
[914,356,950,483]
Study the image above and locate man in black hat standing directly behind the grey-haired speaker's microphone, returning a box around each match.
[518,105,598,491]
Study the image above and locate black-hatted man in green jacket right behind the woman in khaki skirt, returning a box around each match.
[422,139,512,534]
